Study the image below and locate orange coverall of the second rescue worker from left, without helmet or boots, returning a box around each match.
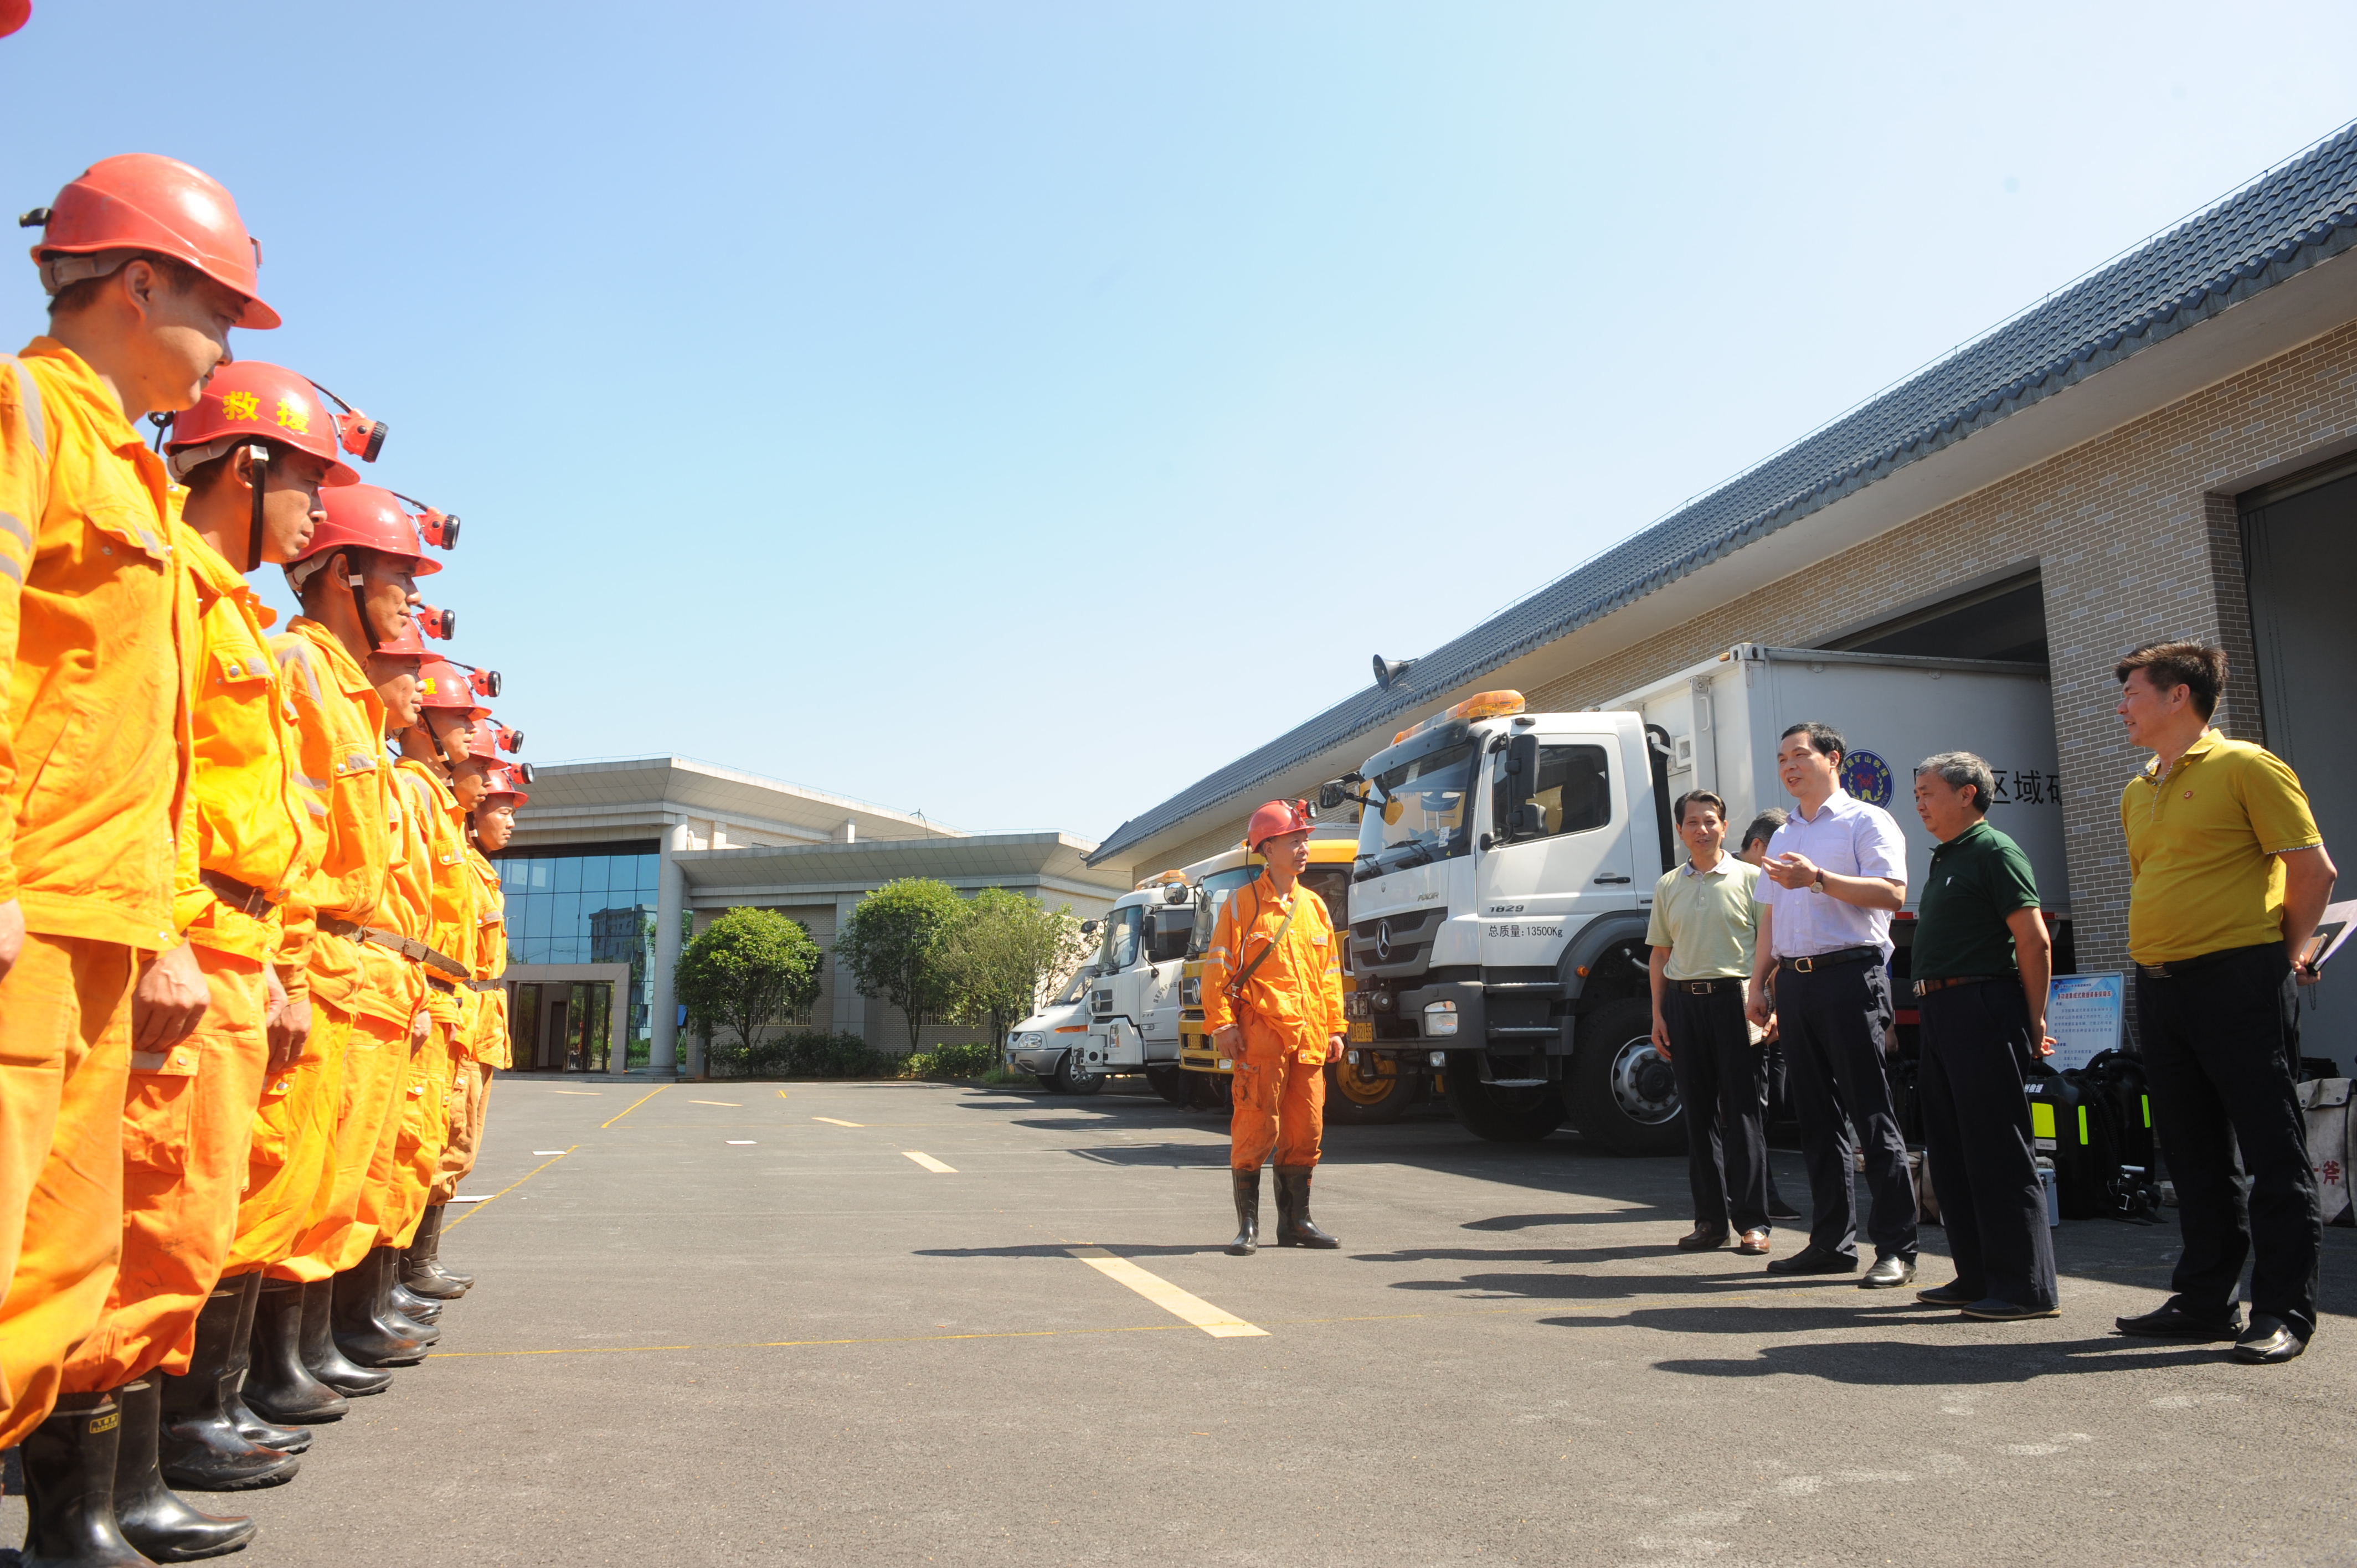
[64,526,325,1394]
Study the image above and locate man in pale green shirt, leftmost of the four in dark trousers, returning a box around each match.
[1645,790,1768,1257]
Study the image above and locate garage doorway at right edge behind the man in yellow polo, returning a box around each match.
[2227,474,2357,1073]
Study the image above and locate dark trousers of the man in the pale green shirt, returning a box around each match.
[1661,981,1768,1231]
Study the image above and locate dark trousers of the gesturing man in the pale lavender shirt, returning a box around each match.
[1775,960,1916,1261]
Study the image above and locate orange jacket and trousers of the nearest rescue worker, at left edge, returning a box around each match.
[0,337,193,1448]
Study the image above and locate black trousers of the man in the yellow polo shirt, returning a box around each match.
[2135,943,2324,1334]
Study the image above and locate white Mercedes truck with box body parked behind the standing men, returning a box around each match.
[1320,644,2070,1153]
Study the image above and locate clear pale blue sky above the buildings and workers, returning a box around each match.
[0,0,2357,837]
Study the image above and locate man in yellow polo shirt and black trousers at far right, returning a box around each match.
[2114,641,2333,1363]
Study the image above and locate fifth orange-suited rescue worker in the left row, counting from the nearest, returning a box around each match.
[384,658,490,1332]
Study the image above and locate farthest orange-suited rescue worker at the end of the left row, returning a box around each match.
[401,721,531,1302]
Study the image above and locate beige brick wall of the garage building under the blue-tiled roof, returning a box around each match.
[1525,323,2357,969]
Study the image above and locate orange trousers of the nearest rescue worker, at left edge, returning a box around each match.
[0,931,135,1448]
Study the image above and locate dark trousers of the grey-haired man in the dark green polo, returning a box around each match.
[1916,976,2060,1309]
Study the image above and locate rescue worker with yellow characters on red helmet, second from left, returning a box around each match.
[44,361,358,1561]
